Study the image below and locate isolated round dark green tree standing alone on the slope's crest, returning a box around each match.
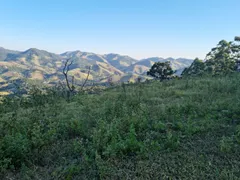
[147,61,174,81]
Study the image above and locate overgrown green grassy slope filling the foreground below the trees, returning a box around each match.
[0,74,240,179]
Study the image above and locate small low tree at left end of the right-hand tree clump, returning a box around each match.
[182,58,205,76]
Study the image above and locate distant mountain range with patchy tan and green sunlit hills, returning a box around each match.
[0,47,193,92]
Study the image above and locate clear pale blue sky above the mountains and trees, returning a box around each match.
[0,0,240,59]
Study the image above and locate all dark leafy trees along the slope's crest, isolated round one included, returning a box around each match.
[147,36,240,81]
